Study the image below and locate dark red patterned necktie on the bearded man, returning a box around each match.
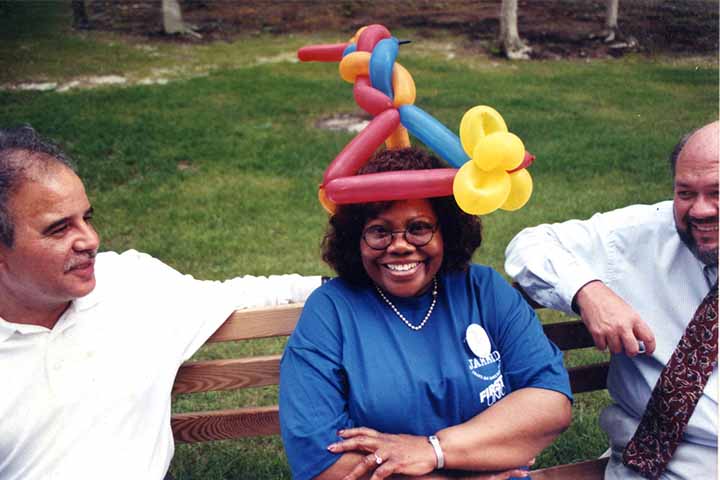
[623,283,718,479]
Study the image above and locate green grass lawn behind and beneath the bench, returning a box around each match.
[0,3,718,480]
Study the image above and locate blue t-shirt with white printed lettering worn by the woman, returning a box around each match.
[280,265,572,479]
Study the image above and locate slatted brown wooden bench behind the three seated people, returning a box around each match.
[172,304,607,480]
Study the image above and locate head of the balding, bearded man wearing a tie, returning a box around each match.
[672,122,720,265]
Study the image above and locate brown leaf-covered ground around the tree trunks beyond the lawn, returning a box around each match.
[83,0,718,58]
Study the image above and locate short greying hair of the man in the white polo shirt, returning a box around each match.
[0,125,76,247]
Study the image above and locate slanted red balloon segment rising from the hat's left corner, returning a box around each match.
[323,108,400,185]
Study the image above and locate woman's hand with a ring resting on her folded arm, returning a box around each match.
[328,427,437,480]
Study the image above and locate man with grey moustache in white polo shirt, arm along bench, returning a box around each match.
[0,127,320,480]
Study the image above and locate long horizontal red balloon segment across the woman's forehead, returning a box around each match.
[325,168,457,205]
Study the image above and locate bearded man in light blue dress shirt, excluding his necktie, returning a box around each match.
[505,122,720,480]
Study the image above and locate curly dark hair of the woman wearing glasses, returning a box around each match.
[322,147,482,285]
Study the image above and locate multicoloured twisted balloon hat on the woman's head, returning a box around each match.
[298,25,535,215]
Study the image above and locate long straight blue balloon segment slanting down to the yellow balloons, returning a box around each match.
[398,105,470,168]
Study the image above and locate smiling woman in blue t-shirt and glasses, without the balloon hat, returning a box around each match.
[280,148,572,479]
